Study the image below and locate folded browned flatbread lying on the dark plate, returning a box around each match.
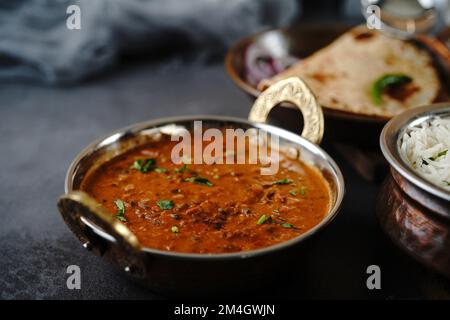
[258,26,440,118]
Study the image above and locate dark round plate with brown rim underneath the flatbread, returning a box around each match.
[225,24,450,124]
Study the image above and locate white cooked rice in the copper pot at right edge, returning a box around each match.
[400,117,450,191]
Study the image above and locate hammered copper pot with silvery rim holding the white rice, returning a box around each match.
[377,103,450,278]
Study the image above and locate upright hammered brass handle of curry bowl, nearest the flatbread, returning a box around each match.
[248,77,324,144]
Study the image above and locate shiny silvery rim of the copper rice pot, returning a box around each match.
[380,102,450,201]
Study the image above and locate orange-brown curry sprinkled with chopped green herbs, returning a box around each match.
[81,131,331,253]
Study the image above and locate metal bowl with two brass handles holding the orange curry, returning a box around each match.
[58,78,344,297]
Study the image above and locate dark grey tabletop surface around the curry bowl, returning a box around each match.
[0,60,448,299]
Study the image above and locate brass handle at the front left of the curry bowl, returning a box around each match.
[58,191,145,276]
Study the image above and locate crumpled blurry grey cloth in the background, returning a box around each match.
[0,0,300,84]
